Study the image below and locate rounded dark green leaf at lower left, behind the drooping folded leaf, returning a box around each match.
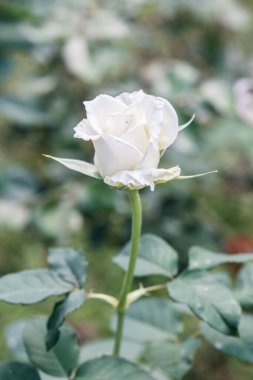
[23,317,79,377]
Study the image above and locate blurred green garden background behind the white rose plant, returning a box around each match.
[0,0,253,380]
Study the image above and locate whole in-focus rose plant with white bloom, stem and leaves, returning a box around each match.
[0,90,253,380]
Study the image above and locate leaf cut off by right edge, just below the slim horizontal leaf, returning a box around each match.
[235,264,253,308]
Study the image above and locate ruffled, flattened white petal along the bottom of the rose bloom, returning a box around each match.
[104,166,181,191]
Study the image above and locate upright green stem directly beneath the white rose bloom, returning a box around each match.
[113,190,142,356]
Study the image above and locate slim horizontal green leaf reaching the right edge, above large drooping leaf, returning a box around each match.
[189,247,253,270]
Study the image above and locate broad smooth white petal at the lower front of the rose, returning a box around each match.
[93,135,141,177]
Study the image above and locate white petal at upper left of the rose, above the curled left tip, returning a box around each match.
[84,94,127,132]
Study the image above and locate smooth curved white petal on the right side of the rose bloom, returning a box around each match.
[158,98,179,150]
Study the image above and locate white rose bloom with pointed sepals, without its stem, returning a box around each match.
[45,90,213,190]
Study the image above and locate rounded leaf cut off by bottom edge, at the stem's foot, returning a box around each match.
[74,356,154,380]
